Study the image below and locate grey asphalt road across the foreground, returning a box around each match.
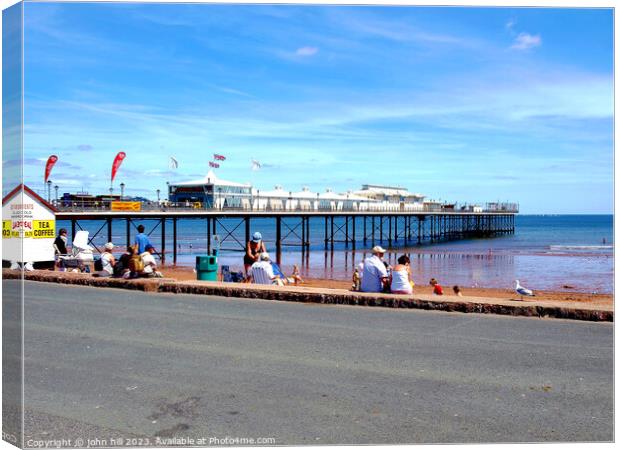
[12,282,613,445]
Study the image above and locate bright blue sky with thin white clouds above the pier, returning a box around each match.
[17,3,613,213]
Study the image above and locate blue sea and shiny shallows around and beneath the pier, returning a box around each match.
[58,215,614,293]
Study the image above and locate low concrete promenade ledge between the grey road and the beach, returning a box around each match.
[3,270,614,322]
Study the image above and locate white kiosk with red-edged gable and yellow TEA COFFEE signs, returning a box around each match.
[2,186,56,262]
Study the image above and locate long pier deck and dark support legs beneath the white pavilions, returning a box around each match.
[56,204,518,264]
